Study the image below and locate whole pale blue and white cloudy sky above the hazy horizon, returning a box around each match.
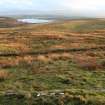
[0,0,105,17]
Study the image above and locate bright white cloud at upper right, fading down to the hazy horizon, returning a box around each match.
[58,0,105,17]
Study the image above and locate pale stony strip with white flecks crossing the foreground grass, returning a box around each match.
[3,89,105,97]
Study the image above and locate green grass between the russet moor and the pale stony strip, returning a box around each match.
[0,60,105,91]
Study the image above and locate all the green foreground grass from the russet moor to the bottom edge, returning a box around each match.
[0,58,105,105]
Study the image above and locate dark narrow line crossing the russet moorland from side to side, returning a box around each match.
[0,46,105,57]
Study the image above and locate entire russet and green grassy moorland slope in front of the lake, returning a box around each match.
[0,20,105,105]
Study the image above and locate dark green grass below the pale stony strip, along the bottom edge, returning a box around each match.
[0,90,105,105]
